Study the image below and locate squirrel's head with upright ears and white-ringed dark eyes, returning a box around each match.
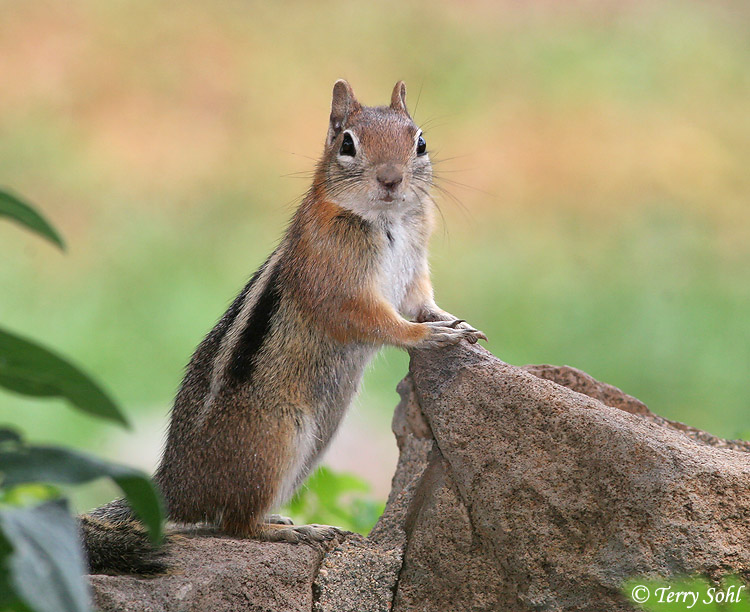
[318,80,432,219]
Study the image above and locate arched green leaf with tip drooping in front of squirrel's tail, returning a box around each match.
[0,446,164,543]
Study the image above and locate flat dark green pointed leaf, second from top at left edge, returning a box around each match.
[0,329,128,426]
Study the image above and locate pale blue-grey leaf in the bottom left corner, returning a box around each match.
[0,500,91,612]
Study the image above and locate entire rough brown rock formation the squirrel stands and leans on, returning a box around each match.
[91,345,750,612]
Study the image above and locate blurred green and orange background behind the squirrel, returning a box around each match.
[0,0,750,508]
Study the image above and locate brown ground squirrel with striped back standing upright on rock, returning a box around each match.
[81,80,486,571]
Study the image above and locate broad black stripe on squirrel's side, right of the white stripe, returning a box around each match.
[227,269,281,383]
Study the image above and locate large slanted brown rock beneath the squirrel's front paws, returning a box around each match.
[394,347,750,611]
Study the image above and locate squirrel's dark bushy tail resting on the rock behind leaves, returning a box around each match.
[79,499,167,574]
